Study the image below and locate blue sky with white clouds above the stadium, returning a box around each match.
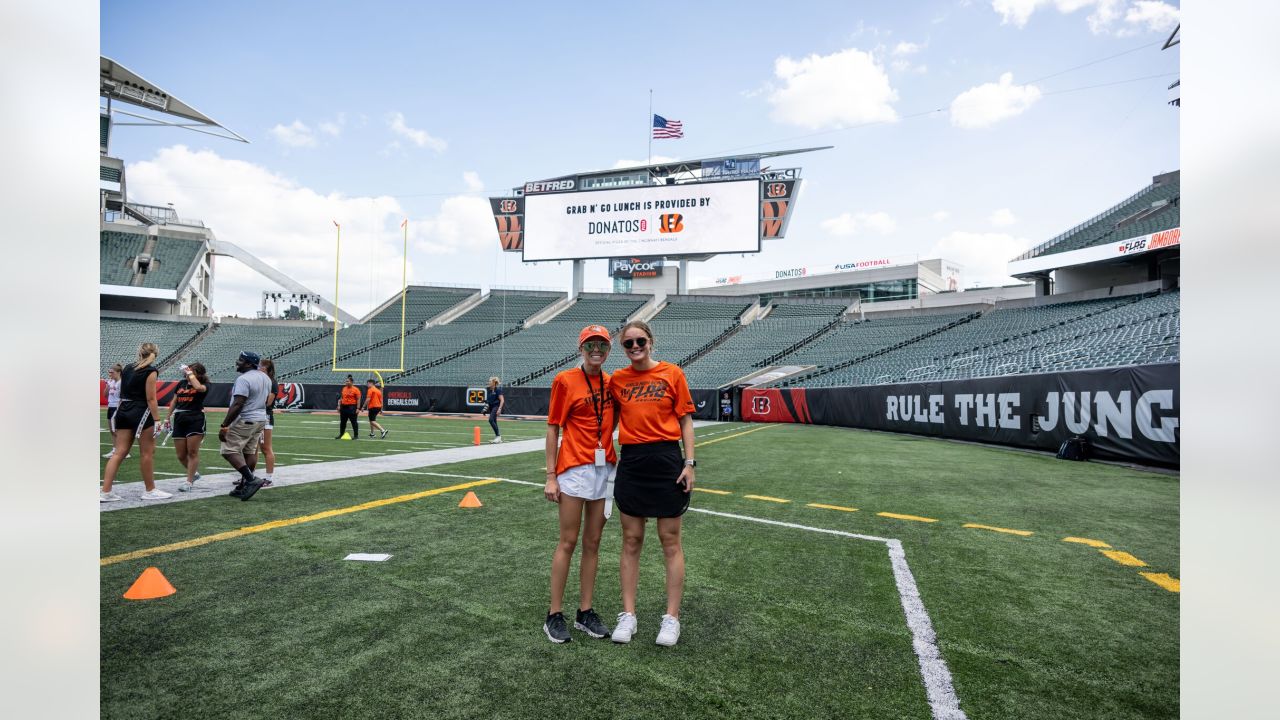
[101,0,1179,315]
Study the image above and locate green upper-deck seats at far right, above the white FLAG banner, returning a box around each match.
[1021,173,1181,259]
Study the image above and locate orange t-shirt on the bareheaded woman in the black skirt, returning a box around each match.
[609,361,694,445]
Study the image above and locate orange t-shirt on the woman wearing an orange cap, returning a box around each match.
[547,368,618,475]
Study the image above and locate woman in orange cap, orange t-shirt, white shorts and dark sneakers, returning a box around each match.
[543,325,618,643]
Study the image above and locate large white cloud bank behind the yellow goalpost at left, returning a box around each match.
[128,145,407,315]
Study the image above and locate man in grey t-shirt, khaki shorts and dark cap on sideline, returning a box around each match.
[218,350,271,500]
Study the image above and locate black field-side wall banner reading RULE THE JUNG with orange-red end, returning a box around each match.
[742,364,1181,466]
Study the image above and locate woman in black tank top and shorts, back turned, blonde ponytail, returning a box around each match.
[99,342,173,502]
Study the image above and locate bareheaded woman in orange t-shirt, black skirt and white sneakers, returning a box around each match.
[609,320,698,647]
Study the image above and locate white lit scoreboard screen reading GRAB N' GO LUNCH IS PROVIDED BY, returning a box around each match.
[524,179,760,263]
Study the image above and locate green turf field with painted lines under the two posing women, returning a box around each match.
[100,415,1179,720]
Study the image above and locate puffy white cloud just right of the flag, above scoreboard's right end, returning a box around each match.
[769,47,897,129]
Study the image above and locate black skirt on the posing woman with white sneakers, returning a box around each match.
[613,441,692,518]
